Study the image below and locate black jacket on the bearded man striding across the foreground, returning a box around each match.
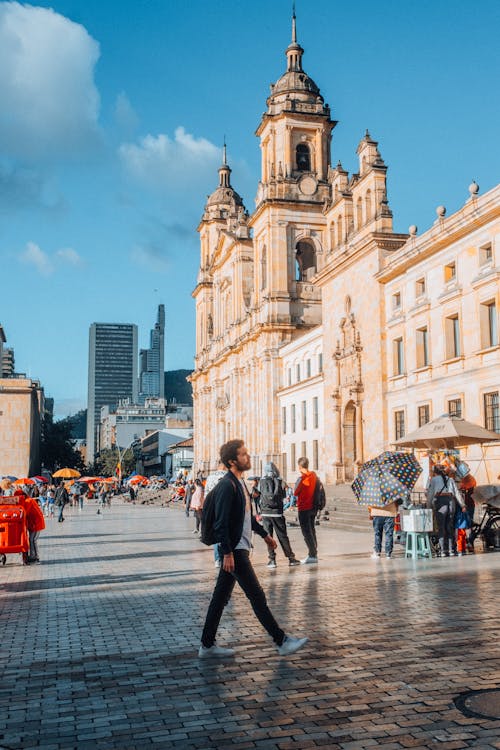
[213,471,267,555]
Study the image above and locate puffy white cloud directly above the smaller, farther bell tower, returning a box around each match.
[119,126,221,189]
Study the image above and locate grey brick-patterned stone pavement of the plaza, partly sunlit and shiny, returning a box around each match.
[0,505,500,750]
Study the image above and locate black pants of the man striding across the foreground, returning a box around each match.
[201,549,285,648]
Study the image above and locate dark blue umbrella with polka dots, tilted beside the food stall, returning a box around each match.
[351,451,422,506]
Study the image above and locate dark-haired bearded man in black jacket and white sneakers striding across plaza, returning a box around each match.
[198,440,308,659]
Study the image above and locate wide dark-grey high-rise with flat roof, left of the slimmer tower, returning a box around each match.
[87,323,137,463]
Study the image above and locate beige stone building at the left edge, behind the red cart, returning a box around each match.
[0,378,43,477]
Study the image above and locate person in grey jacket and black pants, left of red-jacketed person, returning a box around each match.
[258,462,300,568]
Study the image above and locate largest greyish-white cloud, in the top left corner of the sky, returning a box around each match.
[0,2,100,159]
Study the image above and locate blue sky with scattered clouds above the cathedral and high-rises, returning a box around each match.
[0,0,500,416]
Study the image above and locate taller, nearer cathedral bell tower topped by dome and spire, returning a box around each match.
[250,12,336,328]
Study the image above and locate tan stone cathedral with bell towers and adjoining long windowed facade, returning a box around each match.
[191,16,500,485]
